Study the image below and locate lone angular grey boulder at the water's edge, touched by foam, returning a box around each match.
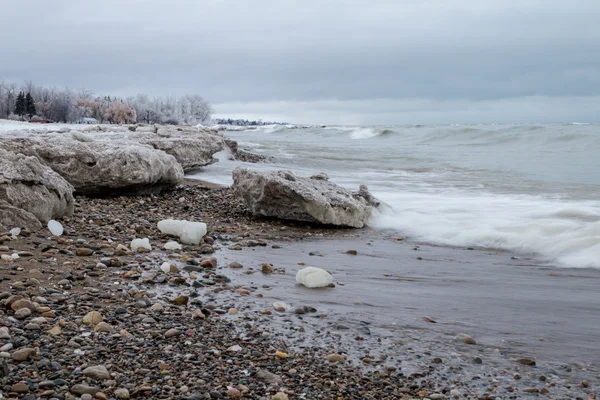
[232,168,379,228]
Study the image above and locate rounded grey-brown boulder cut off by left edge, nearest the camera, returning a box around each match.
[0,148,74,231]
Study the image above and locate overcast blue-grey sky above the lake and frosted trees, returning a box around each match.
[0,0,600,125]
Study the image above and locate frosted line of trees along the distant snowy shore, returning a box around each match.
[0,82,212,125]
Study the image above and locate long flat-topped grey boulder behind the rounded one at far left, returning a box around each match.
[0,138,183,195]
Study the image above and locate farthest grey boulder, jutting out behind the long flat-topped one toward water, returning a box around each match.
[143,133,223,172]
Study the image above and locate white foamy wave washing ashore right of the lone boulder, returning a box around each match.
[371,192,600,268]
